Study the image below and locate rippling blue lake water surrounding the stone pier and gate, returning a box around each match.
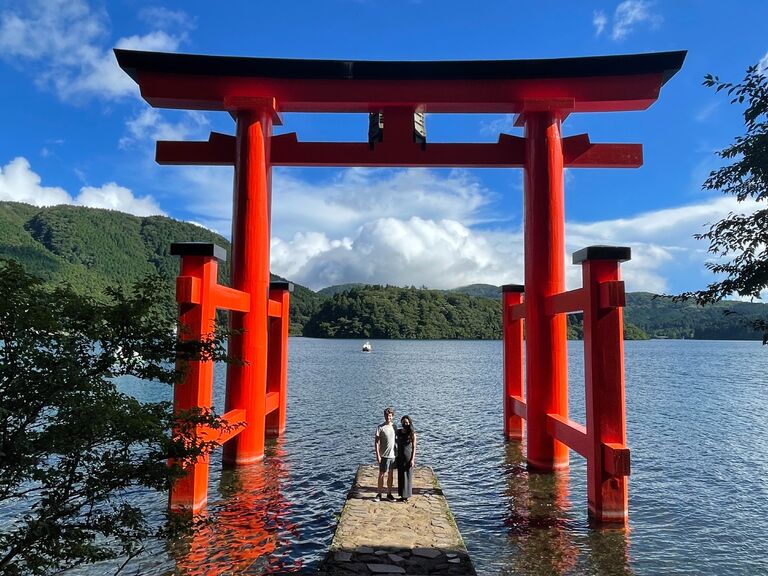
[114,338,768,576]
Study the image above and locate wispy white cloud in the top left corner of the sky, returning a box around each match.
[0,0,190,101]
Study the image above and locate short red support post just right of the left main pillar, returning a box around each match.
[266,281,293,436]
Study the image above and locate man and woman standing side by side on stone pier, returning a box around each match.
[373,408,416,502]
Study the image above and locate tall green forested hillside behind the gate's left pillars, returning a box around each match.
[0,202,321,334]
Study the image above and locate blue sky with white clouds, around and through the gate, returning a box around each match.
[0,0,768,292]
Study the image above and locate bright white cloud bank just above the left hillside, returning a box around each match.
[0,157,165,216]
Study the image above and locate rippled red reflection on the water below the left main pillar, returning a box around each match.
[170,439,302,576]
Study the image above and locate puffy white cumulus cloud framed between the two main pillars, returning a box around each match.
[272,217,523,288]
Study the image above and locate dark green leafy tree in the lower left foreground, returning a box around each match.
[0,260,231,575]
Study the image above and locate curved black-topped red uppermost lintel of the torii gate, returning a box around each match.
[115,49,686,113]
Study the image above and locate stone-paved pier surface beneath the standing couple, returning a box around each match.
[318,465,475,576]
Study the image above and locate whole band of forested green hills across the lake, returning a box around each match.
[0,202,768,339]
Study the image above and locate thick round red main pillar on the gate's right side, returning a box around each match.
[524,112,568,471]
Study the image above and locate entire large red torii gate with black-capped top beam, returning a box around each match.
[115,50,685,523]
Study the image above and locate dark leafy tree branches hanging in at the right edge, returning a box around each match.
[682,66,768,343]
